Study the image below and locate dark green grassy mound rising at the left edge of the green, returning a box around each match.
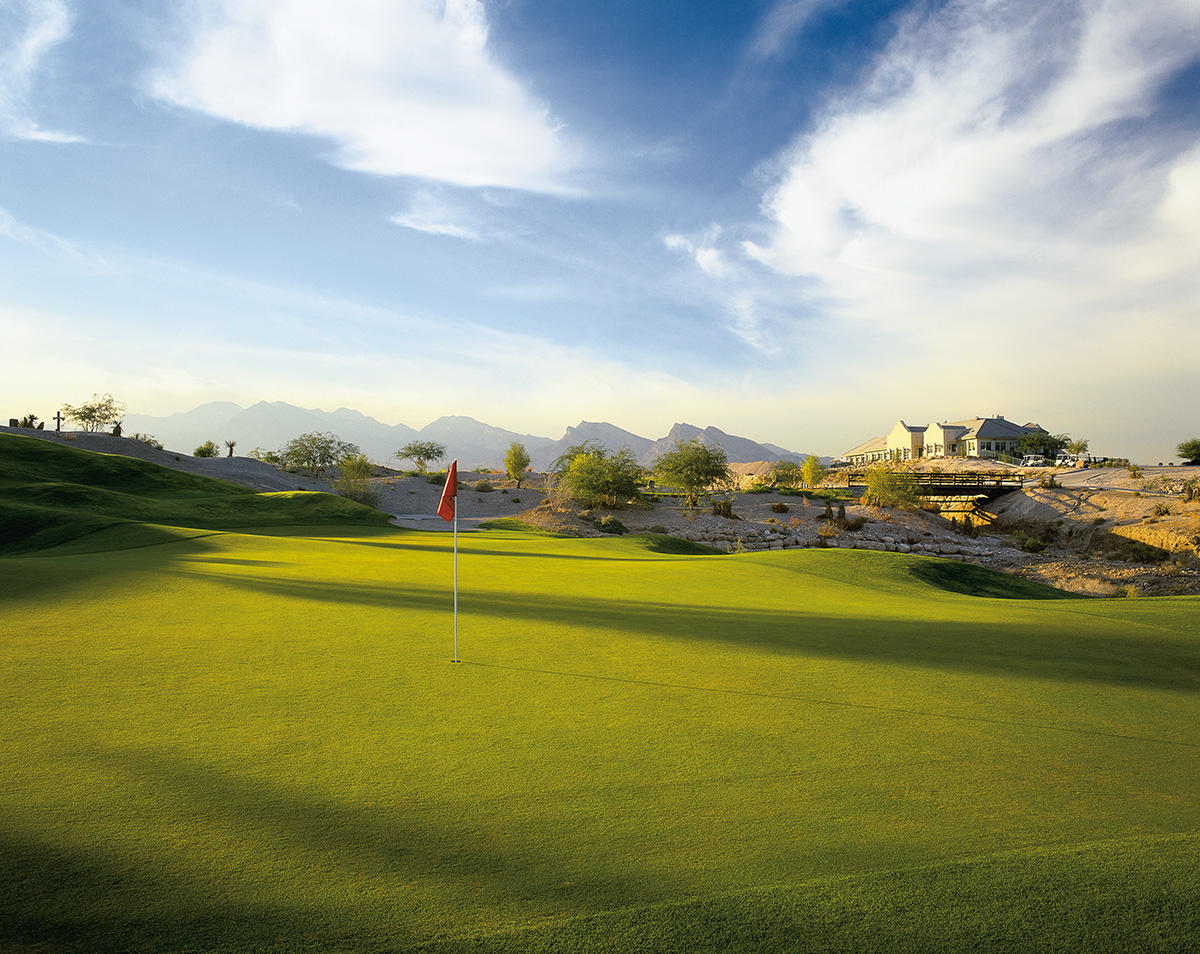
[0,434,386,553]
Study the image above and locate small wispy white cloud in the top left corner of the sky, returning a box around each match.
[0,0,84,143]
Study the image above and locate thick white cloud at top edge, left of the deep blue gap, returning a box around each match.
[151,0,571,192]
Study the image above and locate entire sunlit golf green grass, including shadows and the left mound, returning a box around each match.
[0,436,1200,954]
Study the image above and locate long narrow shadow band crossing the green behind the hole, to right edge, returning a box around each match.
[175,571,1200,692]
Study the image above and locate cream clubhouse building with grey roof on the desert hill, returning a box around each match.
[840,414,1046,467]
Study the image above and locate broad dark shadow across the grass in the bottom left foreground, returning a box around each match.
[0,745,678,954]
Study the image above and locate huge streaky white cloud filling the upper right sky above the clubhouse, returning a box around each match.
[743,0,1200,368]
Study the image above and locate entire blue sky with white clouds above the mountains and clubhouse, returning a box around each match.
[0,0,1200,462]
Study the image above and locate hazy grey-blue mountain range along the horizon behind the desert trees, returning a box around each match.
[122,401,806,470]
